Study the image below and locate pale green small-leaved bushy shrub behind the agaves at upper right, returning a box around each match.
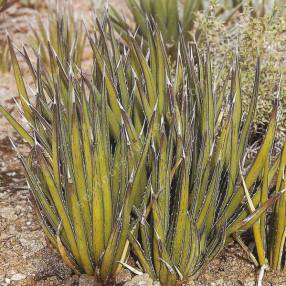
[196,3,286,142]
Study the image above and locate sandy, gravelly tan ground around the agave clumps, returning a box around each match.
[0,1,286,286]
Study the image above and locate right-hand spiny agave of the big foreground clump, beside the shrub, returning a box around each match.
[124,29,280,285]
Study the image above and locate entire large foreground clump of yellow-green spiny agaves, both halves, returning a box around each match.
[0,11,281,285]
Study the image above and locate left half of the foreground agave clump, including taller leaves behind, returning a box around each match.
[0,17,156,283]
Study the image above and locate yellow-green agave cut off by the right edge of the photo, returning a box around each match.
[239,137,286,271]
